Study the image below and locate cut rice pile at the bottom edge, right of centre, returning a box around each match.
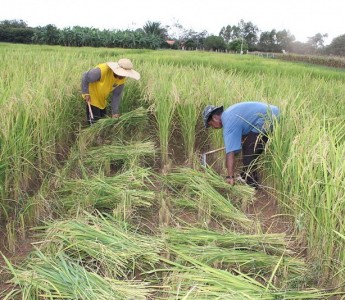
[155,251,331,300]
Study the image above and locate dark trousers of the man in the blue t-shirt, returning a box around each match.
[241,132,268,187]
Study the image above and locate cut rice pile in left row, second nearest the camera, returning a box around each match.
[39,213,163,279]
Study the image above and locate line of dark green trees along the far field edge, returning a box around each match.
[0,20,345,56]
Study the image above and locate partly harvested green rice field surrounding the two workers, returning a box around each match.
[0,44,345,300]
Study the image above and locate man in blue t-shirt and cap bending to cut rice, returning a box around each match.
[203,102,279,187]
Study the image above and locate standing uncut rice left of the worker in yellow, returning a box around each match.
[0,44,145,224]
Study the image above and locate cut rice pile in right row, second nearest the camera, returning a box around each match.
[165,227,310,286]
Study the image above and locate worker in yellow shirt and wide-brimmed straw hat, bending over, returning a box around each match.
[81,58,140,125]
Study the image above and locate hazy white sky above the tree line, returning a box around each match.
[0,0,345,44]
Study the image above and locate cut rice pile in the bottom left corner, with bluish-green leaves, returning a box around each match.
[2,251,152,300]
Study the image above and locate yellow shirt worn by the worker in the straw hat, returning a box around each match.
[89,63,126,109]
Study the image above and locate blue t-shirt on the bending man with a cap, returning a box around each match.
[222,102,279,153]
